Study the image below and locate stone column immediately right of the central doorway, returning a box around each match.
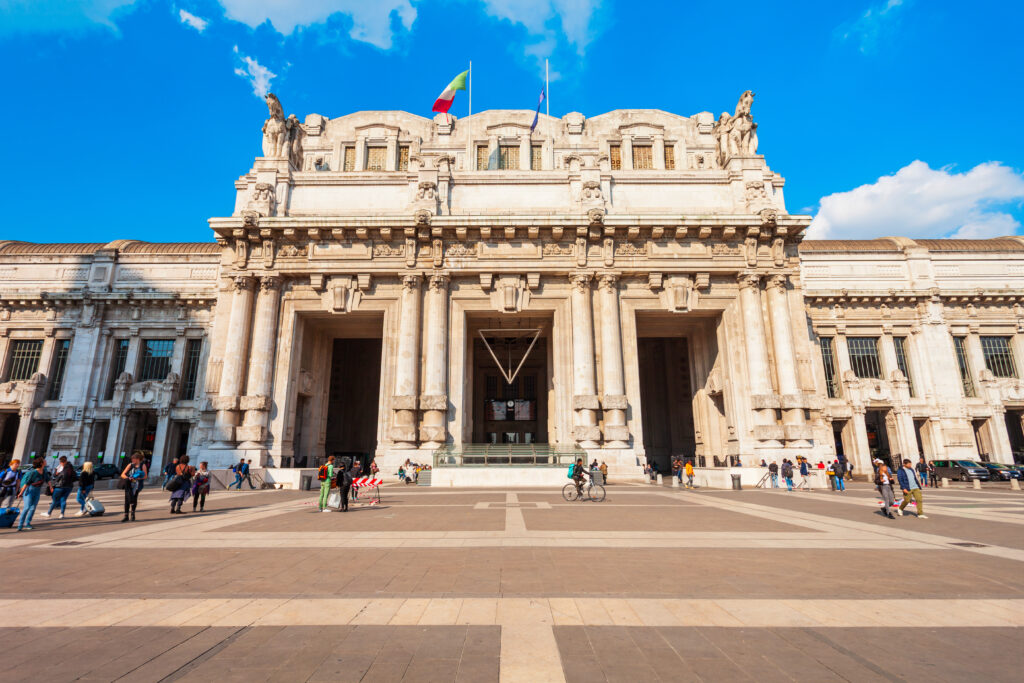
[569,272,601,449]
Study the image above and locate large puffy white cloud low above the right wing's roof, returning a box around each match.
[807,161,1024,240]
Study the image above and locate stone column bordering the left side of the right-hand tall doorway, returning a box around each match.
[598,273,630,449]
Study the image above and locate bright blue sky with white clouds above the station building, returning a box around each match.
[0,0,1024,242]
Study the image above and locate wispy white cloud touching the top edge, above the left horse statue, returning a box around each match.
[220,0,416,49]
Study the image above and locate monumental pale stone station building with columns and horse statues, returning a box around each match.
[0,98,1024,473]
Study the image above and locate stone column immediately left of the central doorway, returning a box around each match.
[420,272,449,449]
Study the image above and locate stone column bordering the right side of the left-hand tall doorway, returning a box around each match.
[391,274,421,449]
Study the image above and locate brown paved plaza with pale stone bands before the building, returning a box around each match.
[0,484,1024,683]
